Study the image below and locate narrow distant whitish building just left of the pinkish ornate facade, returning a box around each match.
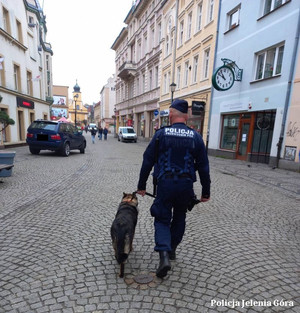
[100,75,116,133]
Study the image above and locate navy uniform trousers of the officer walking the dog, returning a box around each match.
[150,177,194,251]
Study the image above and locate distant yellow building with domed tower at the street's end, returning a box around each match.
[69,81,88,126]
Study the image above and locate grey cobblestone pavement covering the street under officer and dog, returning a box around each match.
[0,134,300,313]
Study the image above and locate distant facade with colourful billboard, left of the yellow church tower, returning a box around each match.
[50,85,69,121]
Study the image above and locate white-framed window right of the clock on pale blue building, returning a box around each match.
[255,45,284,80]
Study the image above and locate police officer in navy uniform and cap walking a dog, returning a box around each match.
[137,99,210,277]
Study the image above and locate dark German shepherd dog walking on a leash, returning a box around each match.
[110,192,138,277]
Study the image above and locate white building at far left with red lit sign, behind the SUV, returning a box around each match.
[0,0,53,147]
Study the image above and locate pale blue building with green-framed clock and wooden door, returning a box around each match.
[208,0,299,165]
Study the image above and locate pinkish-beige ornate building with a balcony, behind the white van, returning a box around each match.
[112,0,166,138]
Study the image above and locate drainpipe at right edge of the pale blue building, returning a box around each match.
[276,11,300,168]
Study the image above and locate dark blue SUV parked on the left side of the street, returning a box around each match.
[26,120,86,156]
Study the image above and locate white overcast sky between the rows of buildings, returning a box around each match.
[39,0,132,104]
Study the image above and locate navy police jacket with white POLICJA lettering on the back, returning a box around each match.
[138,123,210,196]
